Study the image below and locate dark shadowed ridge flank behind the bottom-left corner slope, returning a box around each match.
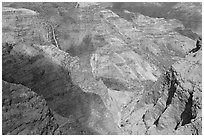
[2,45,116,134]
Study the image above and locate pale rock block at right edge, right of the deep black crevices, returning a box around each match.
[173,50,202,134]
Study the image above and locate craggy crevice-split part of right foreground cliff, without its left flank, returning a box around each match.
[144,51,202,134]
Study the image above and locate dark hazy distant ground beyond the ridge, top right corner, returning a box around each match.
[109,2,202,39]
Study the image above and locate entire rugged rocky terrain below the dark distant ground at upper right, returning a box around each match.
[2,3,202,134]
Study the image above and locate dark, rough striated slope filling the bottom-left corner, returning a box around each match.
[2,81,58,135]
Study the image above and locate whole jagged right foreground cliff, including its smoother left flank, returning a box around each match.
[118,48,202,135]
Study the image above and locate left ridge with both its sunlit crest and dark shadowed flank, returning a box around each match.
[3,6,119,134]
